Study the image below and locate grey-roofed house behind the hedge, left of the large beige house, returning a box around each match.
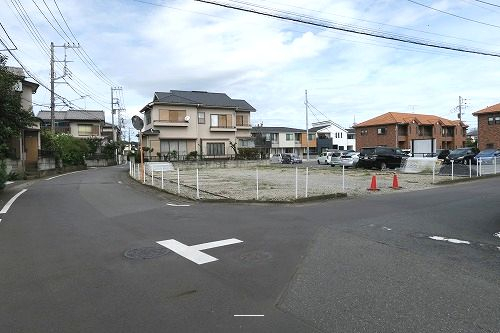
[37,110,105,139]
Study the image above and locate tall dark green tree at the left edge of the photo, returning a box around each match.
[0,54,35,146]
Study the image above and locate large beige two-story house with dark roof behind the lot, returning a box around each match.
[140,90,255,159]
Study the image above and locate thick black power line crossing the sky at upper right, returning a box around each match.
[194,0,500,57]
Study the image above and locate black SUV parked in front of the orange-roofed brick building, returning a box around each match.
[356,147,408,170]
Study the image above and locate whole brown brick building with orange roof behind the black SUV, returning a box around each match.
[353,112,467,154]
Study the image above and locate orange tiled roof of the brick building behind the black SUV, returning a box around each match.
[354,112,465,127]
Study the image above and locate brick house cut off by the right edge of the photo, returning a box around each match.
[473,103,500,150]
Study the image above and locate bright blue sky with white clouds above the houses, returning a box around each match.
[0,0,500,135]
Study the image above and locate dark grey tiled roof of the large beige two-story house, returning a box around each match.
[153,90,255,111]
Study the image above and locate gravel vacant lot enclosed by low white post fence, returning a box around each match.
[135,163,466,201]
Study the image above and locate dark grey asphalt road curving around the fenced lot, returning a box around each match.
[0,167,500,332]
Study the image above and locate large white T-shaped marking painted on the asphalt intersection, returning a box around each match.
[156,238,243,265]
